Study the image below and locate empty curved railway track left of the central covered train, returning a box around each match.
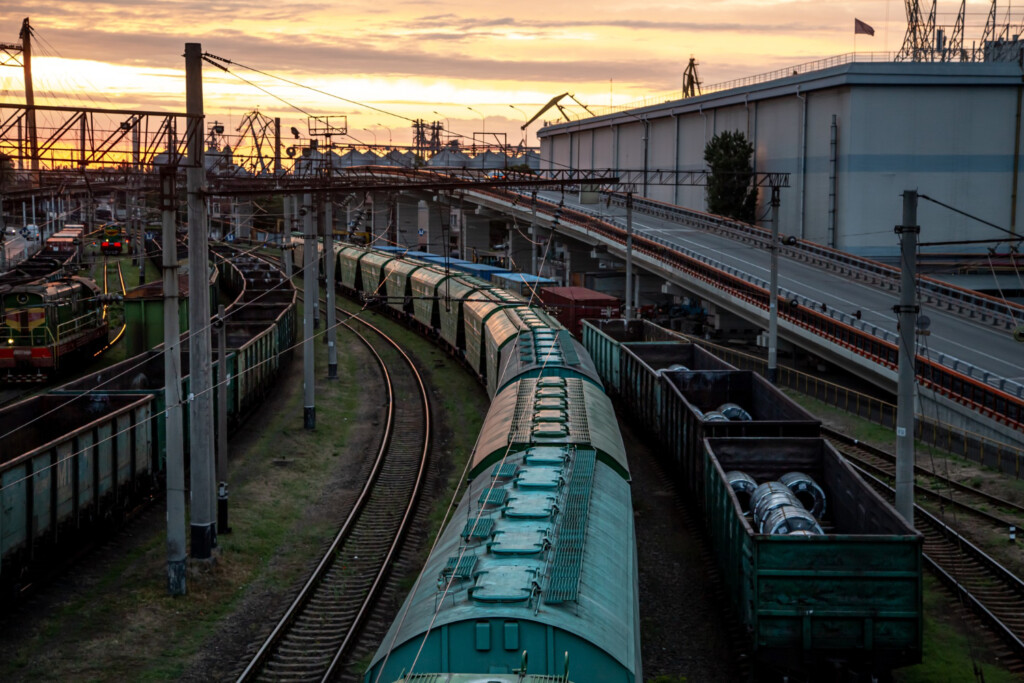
[238,290,430,682]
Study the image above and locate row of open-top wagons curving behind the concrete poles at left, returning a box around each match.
[0,247,296,594]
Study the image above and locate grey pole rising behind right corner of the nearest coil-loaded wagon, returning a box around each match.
[896,189,921,526]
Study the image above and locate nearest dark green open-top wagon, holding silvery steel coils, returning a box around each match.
[701,438,923,680]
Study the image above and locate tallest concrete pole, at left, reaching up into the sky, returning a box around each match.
[185,43,217,560]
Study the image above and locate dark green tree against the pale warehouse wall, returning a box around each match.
[705,130,758,223]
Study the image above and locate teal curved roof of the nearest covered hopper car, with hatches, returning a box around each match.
[371,449,640,680]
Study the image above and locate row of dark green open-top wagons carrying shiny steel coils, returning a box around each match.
[584,321,924,681]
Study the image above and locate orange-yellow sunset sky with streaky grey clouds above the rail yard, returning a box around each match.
[0,0,1002,150]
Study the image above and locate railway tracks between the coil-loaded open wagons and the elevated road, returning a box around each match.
[823,429,1024,675]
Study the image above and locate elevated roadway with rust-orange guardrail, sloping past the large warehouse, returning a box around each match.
[458,187,1024,445]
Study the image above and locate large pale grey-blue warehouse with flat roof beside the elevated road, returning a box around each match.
[538,54,1024,258]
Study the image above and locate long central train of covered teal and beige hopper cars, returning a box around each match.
[311,247,643,683]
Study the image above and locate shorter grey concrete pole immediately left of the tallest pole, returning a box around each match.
[160,166,186,595]
